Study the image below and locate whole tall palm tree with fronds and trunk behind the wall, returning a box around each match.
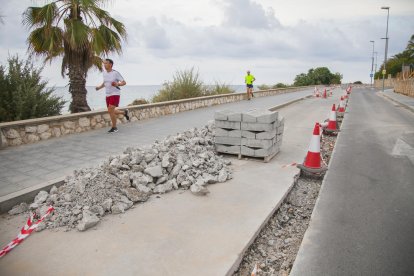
[23,0,126,113]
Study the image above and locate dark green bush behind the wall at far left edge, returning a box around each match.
[0,56,66,122]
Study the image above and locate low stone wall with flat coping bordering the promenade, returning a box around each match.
[0,87,308,148]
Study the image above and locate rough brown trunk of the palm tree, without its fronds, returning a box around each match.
[68,64,91,113]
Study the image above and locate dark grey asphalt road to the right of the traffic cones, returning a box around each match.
[290,89,414,275]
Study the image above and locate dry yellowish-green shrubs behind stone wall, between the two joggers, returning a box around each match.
[151,68,235,103]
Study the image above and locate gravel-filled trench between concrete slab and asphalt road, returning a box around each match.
[233,131,337,276]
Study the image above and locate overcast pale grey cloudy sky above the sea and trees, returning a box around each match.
[0,0,414,86]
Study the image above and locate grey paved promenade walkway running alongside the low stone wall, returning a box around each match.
[0,90,313,213]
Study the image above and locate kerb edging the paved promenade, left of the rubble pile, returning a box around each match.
[0,177,65,214]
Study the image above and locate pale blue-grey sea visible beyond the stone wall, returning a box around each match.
[53,85,246,114]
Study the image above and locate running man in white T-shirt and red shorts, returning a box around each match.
[95,58,129,133]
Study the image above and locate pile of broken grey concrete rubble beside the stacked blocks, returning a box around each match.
[9,123,232,231]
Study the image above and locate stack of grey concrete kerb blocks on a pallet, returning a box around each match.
[214,109,284,162]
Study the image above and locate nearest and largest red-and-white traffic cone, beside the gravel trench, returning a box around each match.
[297,123,327,174]
